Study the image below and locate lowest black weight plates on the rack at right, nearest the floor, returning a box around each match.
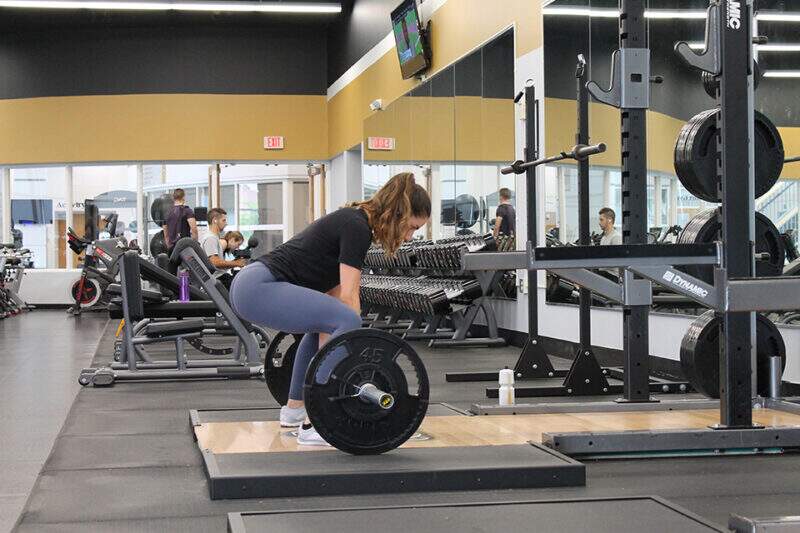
[681,311,786,398]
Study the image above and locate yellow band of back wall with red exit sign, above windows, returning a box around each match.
[0,94,328,164]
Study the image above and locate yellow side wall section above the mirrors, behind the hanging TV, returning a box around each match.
[328,0,542,156]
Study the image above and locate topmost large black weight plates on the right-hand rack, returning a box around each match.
[674,109,785,202]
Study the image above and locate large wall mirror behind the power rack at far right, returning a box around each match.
[543,0,800,312]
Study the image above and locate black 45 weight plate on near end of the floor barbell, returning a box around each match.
[304,329,429,455]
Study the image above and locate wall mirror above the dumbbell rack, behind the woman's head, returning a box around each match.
[363,30,514,243]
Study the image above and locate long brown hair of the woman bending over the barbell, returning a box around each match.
[350,172,431,255]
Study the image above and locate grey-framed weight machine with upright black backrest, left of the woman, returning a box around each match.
[78,251,263,386]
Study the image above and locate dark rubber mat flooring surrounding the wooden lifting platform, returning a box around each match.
[9,315,800,532]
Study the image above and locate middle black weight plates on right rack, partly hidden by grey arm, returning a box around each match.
[677,209,786,283]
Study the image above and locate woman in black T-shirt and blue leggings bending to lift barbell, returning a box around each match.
[231,172,431,446]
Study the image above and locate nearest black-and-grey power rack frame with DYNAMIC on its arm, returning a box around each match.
[466,0,800,456]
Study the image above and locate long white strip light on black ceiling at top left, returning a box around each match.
[0,0,342,13]
